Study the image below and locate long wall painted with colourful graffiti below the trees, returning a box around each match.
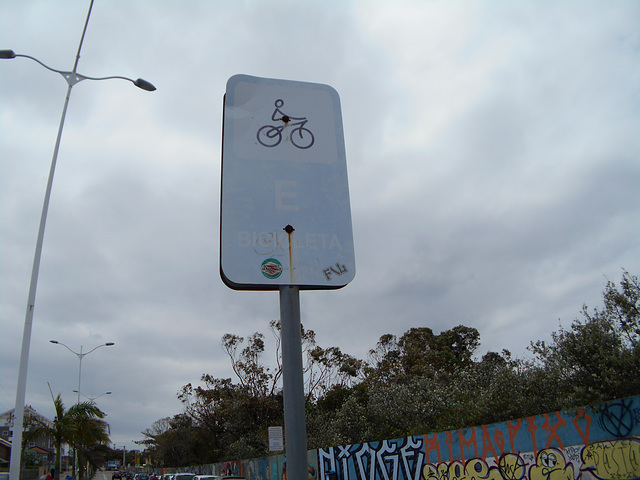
[188,397,640,480]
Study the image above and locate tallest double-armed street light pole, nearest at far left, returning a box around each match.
[0,0,156,480]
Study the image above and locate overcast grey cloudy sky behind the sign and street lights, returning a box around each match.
[0,0,640,448]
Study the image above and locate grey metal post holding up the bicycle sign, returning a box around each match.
[280,285,308,480]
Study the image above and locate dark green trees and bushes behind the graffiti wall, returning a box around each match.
[143,272,640,466]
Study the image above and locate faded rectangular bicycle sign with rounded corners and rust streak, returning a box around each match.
[220,75,355,290]
